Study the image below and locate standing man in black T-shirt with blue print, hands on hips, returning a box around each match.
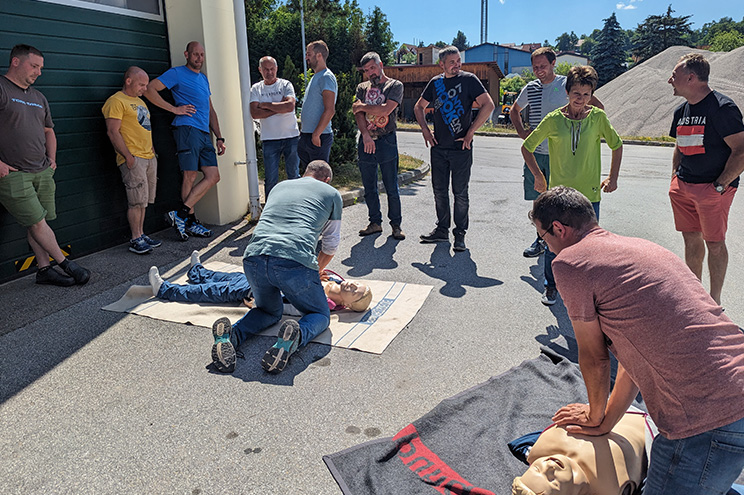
[413,46,494,251]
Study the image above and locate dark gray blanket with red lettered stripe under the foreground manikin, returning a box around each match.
[323,347,645,495]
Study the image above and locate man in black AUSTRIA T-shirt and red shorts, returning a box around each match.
[669,53,744,304]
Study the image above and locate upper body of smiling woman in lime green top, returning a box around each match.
[522,65,623,203]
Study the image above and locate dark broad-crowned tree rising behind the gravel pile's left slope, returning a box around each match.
[633,5,692,61]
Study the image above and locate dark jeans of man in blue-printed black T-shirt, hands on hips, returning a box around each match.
[431,146,473,236]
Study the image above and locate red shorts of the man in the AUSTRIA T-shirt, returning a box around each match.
[669,176,737,242]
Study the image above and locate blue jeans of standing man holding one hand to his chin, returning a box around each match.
[358,132,401,225]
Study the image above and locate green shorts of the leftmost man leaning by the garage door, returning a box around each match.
[0,167,57,227]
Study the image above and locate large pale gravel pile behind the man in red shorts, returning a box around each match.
[597,46,744,137]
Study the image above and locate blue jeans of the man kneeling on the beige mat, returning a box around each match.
[231,255,331,348]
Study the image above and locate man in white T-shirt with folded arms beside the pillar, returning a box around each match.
[251,56,300,200]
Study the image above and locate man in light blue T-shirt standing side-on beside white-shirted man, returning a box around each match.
[297,40,338,168]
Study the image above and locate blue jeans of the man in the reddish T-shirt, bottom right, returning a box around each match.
[643,416,744,495]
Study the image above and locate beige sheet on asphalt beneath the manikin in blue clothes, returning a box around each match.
[102,262,432,354]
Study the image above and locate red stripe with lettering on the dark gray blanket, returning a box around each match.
[393,424,495,495]
